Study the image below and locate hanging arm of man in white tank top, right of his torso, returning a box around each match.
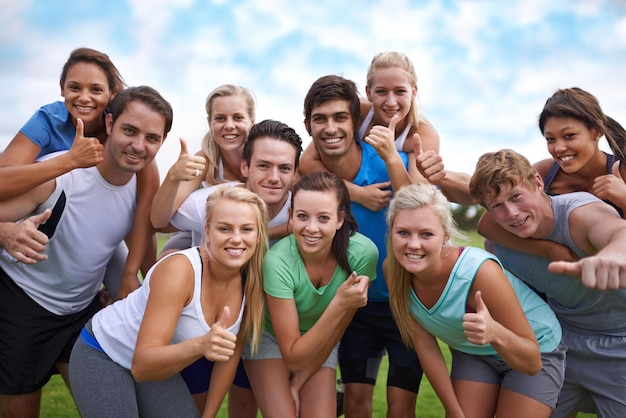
[117,160,159,299]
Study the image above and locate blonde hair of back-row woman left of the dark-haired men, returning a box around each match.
[202,84,256,184]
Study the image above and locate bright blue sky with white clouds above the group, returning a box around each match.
[0,0,626,176]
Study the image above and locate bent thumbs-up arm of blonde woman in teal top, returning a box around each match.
[463,260,541,375]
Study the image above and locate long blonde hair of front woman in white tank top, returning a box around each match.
[205,186,269,352]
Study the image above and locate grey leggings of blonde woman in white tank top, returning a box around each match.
[70,338,200,418]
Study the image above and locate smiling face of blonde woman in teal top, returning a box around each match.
[389,206,450,274]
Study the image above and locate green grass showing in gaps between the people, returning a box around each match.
[41,232,595,418]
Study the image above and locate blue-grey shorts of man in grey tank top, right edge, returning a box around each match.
[552,327,626,418]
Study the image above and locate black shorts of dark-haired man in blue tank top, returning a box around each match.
[339,302,423,393]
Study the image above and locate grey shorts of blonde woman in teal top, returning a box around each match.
[450,344,567,408]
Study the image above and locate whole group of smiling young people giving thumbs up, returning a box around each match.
[0,48,626,418]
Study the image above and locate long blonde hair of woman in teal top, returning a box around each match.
[385,184,465,347]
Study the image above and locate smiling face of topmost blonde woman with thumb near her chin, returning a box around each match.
[365,67,417,126]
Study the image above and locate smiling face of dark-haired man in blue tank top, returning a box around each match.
[308,100,355,157]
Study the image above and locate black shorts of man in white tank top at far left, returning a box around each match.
[0,269,100,395]
